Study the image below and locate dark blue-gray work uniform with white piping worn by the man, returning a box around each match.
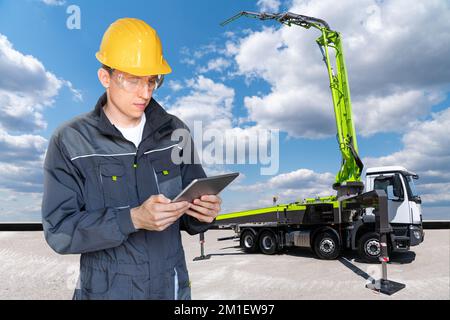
[42,94,211,299]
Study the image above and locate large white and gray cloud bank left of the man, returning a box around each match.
[0,33,79,221]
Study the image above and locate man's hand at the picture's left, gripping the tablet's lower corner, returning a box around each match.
[131,194,192,231]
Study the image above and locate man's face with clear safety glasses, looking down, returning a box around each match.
[100,70,157,119]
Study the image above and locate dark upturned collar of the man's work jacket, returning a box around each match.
[94,92,175,140]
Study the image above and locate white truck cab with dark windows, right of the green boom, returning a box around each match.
[363,166,424,252]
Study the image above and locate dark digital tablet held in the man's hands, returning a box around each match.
[172,172,239,202]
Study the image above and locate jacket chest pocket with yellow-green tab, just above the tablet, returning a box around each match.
[152,158,182,199]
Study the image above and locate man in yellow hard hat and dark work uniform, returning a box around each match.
[42,18,221,299]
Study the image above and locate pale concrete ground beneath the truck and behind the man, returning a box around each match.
[0,230,450,300]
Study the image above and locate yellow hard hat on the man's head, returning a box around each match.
[95,18,172,76]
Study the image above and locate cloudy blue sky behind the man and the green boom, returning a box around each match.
[0,0,450,221]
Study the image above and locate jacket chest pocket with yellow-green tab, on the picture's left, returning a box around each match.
[99,163,129,208]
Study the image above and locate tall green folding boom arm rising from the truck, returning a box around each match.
[221,11,363,187]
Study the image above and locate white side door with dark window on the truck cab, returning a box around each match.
[374,174,411,224]
